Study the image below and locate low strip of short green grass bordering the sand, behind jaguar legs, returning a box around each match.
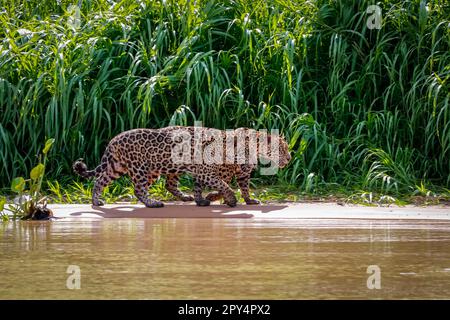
[44,177,450,206]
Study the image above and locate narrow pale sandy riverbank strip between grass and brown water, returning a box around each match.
[49,202,450,220]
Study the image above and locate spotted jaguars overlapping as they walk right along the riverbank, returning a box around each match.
[73,126,291,208]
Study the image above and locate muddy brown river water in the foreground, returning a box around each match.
[0,219,450,299]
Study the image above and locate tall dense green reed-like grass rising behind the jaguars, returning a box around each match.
[0,0,450,200]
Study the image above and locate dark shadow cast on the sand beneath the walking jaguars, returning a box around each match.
[70,204,287,219]
